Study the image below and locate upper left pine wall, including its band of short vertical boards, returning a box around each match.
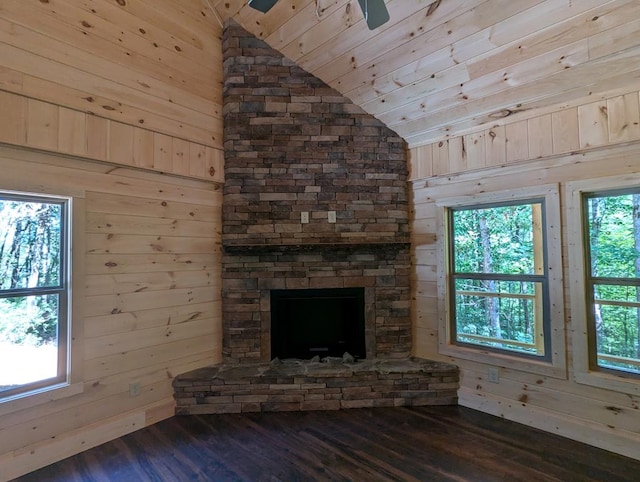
[0,0,224,182]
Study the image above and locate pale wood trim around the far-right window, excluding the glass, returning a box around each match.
[566,175,640,395]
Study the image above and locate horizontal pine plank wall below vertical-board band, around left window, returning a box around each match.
[0,148,222,480]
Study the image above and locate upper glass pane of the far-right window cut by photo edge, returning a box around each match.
[587,193,640,278]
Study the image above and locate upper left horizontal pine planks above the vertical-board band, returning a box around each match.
[0,0,222,148]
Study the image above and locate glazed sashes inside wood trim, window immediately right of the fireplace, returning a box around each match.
[448,199,550,360]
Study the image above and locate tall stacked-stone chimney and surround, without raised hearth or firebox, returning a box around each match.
[222,20,411,363]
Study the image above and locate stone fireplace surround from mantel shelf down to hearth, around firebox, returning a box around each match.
[222,245,411,363]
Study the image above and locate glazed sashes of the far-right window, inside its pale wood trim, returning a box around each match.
[583,188,640,374]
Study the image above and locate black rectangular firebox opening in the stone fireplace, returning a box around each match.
[271,288,366,359]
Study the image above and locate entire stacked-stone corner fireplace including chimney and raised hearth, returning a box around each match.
[174,21,458,414]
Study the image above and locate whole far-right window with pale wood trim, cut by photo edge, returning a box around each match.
[567,175,640,394]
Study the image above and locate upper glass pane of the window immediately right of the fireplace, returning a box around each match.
[452,203,542,274]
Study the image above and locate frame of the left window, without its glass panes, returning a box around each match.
[0,189,73,404]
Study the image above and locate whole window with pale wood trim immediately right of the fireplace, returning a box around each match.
[434,184,567,378]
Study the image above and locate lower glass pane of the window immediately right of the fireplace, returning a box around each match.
[455,279,544,355]
